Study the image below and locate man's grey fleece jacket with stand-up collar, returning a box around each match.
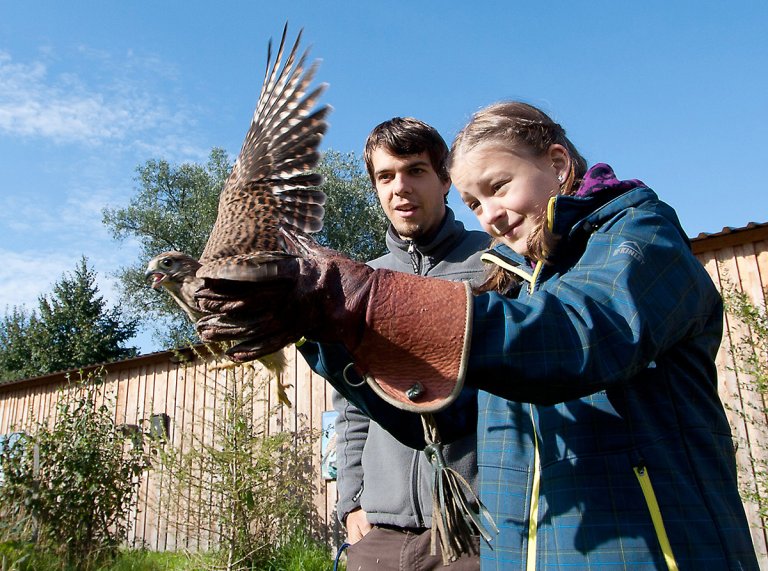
[333,207,489,528]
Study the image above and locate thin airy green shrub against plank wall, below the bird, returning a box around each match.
[160,350,320,571]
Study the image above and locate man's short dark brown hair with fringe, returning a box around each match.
[363,117,451,187]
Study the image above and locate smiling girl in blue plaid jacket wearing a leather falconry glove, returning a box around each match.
[199,103,758,570]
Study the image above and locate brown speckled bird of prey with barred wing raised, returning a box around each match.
[146,25,331,384]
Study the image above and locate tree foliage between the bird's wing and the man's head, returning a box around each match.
[317,150,389,262]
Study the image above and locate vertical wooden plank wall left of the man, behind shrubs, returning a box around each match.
[0,346,343,551]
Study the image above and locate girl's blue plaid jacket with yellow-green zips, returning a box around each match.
[467,182,758,571]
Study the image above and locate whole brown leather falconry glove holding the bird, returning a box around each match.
[195,230,472,413]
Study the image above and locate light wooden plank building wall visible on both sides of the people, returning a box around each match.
[0,224,768,569]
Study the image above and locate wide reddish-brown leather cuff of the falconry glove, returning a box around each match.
[353,270,472,413]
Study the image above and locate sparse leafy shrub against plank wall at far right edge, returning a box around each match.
[723,287,768,522]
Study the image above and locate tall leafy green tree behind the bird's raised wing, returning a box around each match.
[103,148,386,347]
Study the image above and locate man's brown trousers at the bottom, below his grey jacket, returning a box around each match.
[347,527,480,571]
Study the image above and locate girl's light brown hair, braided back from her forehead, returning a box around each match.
[448,101,587,291]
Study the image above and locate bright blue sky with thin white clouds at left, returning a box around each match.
[0,0,768,349]
